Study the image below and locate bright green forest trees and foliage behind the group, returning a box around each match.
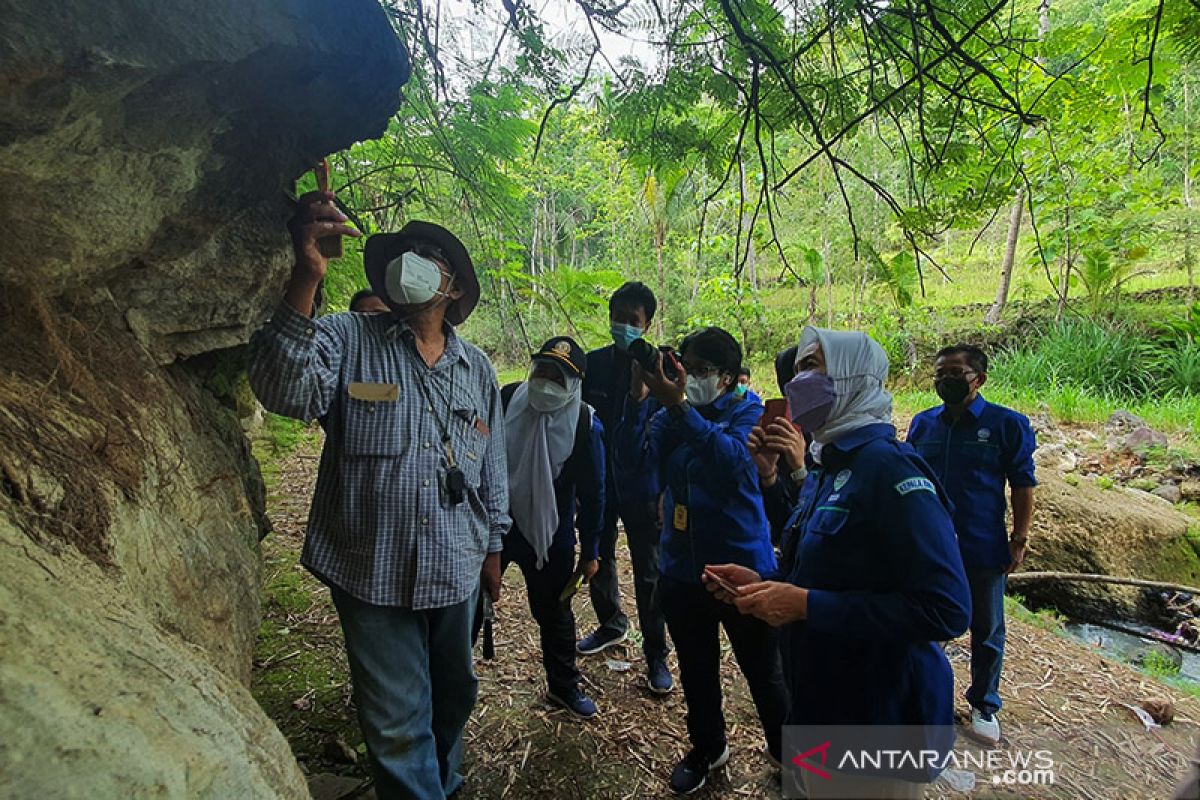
[307,0,1200,359]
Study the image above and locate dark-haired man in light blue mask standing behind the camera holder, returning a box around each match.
[578,281,673,694]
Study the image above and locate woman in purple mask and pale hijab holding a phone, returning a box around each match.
[706,327,971,798]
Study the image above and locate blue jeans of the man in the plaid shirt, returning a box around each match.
[331,587,479,800]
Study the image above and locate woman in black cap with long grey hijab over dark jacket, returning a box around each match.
[500,336,605,720]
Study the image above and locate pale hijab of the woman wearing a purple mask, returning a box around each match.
[796,325,892,450]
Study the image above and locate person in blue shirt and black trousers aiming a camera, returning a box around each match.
[616,327,787,794]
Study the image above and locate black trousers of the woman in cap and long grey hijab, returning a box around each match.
[500,544,581,694]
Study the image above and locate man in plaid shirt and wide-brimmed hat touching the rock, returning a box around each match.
[250,192,510,800]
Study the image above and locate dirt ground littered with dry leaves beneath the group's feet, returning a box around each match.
[253,438,1200,800]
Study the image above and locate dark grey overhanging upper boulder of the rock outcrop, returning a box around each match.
[0,0,407,362]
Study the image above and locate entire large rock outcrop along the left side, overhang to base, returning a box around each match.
[0,0,408,798]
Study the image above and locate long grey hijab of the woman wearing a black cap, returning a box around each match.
[504,373,583,570]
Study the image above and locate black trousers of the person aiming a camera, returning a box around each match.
[659,577,787,757]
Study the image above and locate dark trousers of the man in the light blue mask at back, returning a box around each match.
[588,501,667,660]
